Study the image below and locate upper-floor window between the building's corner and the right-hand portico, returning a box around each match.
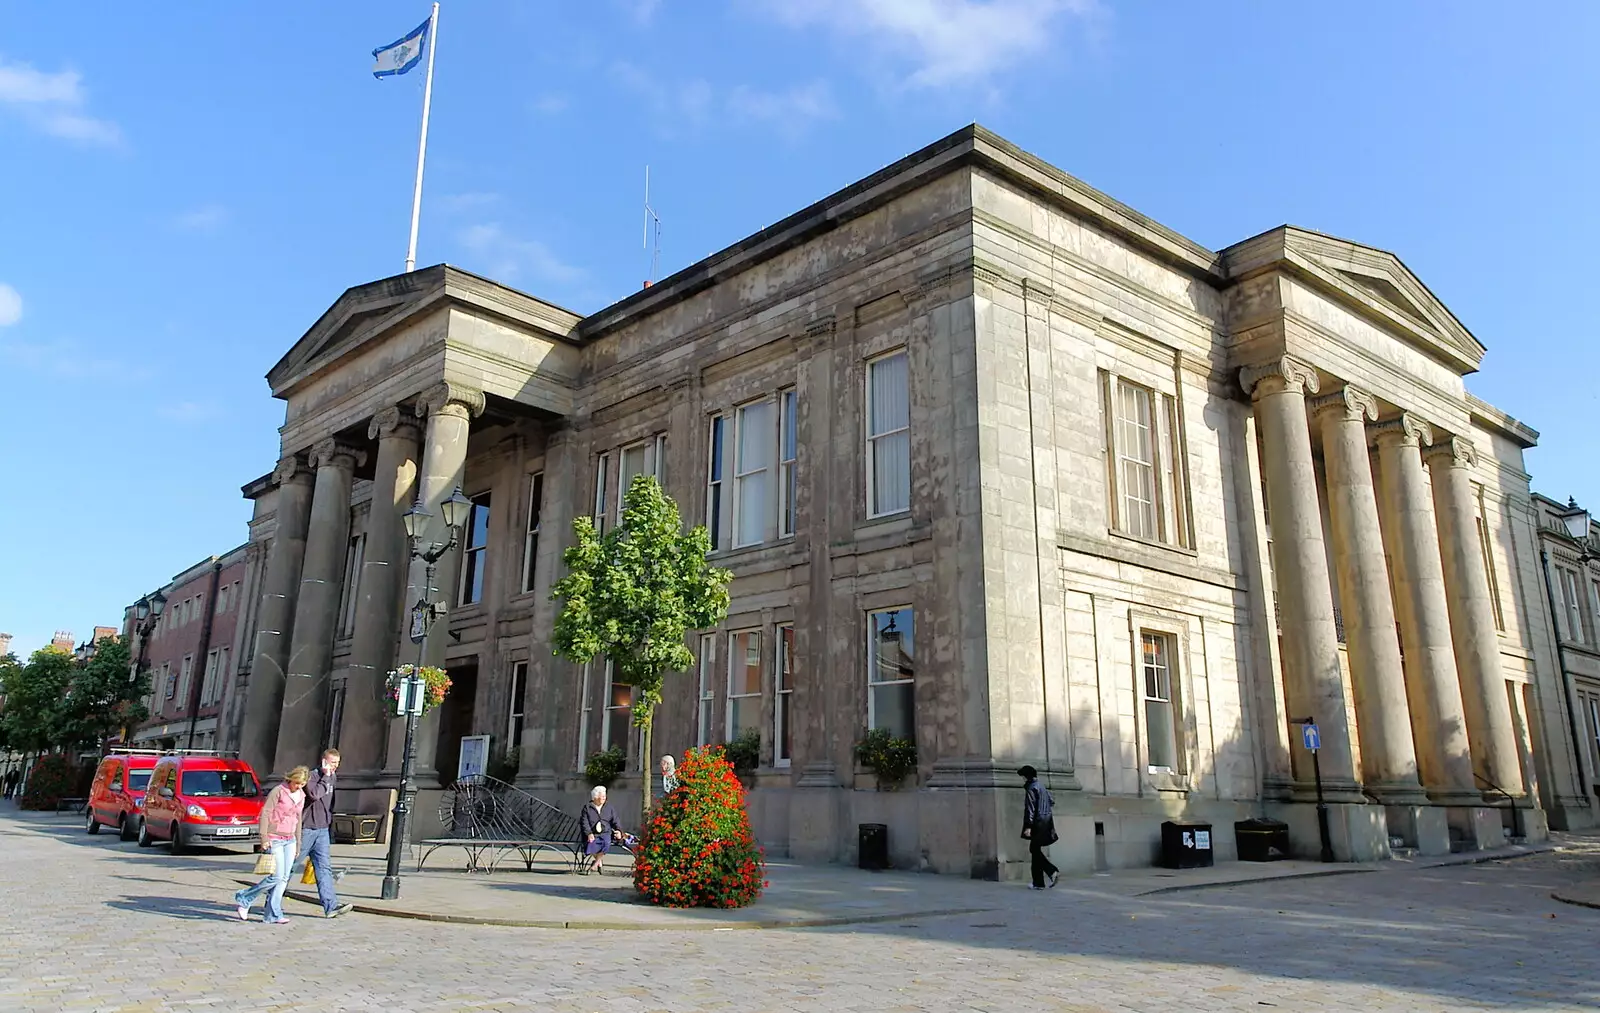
[1101,371,1194,549]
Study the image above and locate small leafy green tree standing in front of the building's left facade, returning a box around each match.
[552,475,733,811]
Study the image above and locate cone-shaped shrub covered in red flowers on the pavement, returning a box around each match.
[634,746,766,907]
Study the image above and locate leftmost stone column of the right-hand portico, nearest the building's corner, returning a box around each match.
[1238,355,1366,802]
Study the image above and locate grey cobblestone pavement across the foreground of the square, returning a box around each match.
[0,807,1600,1013]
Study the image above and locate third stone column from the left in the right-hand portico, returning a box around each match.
[1371,414,1493,805]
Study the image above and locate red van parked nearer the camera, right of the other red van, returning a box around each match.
[139,755,266,855]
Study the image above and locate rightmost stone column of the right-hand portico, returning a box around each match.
[1427,437,1523,797]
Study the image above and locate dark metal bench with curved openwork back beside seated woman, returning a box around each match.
[416,775,626,872]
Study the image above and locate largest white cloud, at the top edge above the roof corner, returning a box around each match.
[754,0,1098,88]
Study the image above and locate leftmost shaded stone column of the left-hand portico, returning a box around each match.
[238,454,312,779]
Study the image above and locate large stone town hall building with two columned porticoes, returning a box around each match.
[222,126,1594,877]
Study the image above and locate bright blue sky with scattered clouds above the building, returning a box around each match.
[0,0,1600,651]
